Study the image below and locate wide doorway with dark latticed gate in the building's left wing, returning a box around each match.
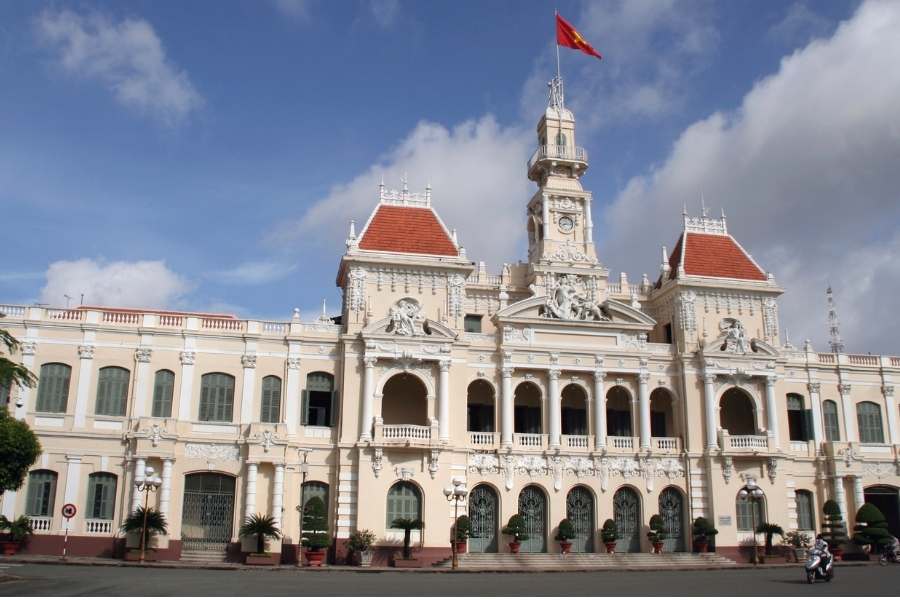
[181,473,234,552]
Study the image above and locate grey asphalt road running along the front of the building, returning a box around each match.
[0,564,900,596]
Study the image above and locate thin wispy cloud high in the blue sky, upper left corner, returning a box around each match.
[36,10,203,125]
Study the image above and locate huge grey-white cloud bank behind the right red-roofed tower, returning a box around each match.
[601,1,900,352]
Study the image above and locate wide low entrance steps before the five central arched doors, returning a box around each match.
[434,552,736,571]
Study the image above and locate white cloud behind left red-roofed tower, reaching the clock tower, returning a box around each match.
[270,116,534,267]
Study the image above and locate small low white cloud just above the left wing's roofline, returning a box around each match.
[41,258,191,309]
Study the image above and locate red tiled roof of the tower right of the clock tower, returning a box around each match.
[669,231,766,281]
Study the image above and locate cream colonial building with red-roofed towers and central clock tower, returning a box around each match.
[0,82,900,560]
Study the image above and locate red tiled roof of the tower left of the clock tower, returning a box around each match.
[359,204,459,256]
